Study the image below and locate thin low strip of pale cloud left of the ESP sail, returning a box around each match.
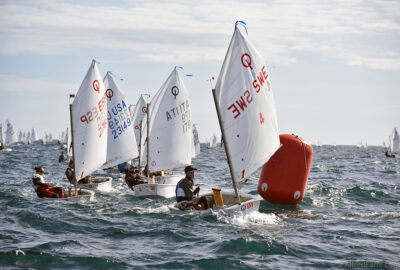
[0,74,79,93]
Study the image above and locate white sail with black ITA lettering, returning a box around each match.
[142,68,193,171]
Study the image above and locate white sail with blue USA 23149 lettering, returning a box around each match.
[103,72,139,168]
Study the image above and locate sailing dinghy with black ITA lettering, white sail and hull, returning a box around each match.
[134,67,193,198]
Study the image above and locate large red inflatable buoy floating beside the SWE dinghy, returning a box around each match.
[258,134,313,204]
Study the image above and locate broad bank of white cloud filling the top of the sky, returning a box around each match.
[0,0,400,70]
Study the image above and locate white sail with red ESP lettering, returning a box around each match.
[72,60,107,179]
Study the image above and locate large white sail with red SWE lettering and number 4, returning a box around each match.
[216,26,280,179]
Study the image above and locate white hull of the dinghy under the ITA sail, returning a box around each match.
[133,175,185,198]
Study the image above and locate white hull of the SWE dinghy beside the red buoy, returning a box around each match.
[168,193,262,216]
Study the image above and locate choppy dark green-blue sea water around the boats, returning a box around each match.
[0,144,400,269]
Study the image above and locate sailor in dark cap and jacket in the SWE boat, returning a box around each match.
[175,165,200,210]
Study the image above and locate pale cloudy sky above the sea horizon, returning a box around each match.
[0,0,400,145]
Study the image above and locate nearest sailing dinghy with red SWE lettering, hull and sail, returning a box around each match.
[169,23,280,215]
